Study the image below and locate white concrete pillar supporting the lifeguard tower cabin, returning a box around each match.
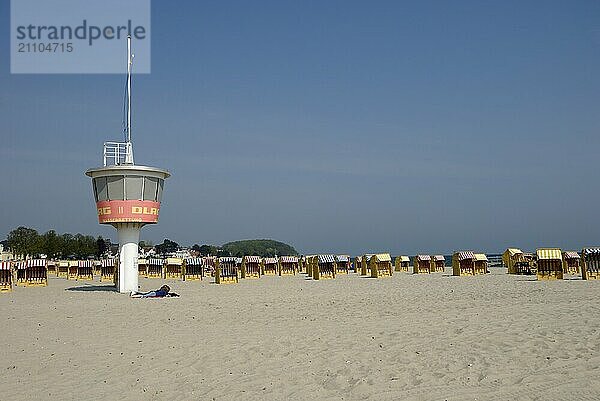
[115,223,142,293]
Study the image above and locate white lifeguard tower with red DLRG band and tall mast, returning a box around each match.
[85,36,170,293]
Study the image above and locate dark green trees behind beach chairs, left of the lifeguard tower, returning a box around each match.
[6,226,110,259]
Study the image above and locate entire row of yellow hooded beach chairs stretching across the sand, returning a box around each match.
[0,247,600,292]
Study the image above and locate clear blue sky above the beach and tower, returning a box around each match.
[0,0,600,255]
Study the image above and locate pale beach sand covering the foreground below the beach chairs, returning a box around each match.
[0,268,600,401]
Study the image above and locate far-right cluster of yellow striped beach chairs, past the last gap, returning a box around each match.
[502,247,600,280]
